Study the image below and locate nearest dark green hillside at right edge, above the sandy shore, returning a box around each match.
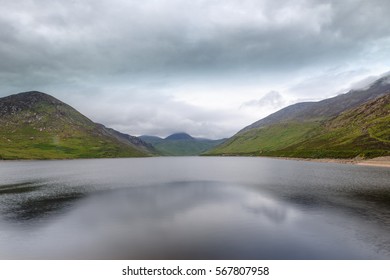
[283,94,390,158]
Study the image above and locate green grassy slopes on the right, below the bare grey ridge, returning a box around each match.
[206,94,390,158]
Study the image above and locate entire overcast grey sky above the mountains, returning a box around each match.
[0,0,390,138]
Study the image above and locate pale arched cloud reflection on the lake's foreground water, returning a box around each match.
[0,181,384,259]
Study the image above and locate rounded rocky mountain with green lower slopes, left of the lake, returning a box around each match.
[0,91,153,159]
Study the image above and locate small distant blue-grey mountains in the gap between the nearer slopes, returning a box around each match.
[139,132,226,156]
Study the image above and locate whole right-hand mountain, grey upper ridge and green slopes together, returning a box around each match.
[207,76,390,158]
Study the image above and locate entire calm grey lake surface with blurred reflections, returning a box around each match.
[0,157,390,259]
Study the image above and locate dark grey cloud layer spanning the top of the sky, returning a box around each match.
[0,0,390,83]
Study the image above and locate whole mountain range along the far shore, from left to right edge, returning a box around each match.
[0,76,390,159]
